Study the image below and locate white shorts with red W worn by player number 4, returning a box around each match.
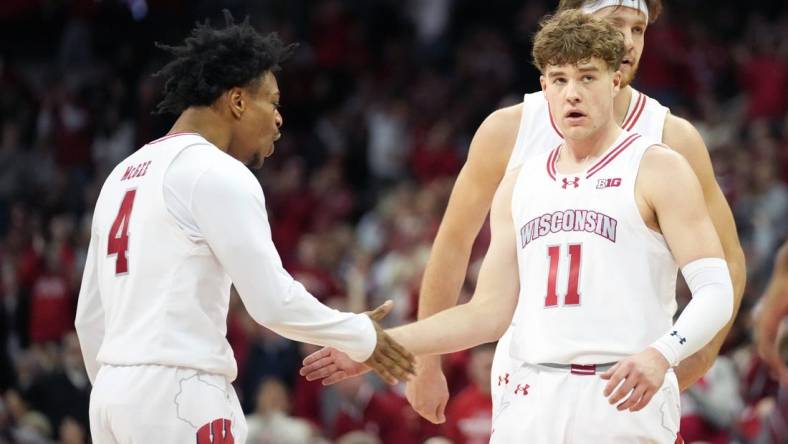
[90,365,247,444]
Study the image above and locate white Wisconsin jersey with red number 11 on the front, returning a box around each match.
[510,131,678,364]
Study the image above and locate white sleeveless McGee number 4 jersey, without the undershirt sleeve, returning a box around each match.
[93,134,237,380]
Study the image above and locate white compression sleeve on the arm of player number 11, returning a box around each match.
[651,258,733,367]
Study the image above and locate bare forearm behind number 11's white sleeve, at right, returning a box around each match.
[676,245,747,390]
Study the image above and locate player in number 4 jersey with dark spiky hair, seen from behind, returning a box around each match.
[76,13,413,444]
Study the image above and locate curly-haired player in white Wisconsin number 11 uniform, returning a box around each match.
[304,10,734,443]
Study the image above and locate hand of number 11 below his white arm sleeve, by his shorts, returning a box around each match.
[600,347,670,412]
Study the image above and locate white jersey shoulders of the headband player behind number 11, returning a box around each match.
[506,88,668,171]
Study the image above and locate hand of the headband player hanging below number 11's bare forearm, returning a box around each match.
[405,356,449,424]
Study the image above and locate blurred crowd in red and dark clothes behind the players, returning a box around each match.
[0,0,788,444]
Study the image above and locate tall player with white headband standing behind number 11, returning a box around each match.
[406,0,746,423]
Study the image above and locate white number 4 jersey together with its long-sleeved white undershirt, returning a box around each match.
[76,134,376,380]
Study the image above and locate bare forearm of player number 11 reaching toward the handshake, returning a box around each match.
[387,301,504,355]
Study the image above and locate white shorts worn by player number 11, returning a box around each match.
[490,364,681,444]
